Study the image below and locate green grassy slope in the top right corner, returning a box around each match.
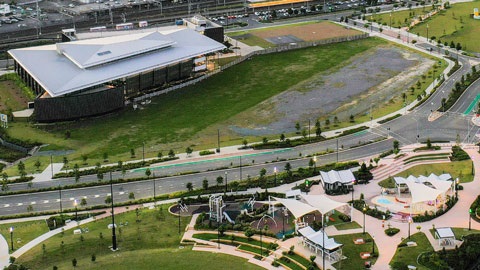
[410,1,480,52]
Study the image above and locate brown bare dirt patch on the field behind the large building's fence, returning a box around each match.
[253,22,360,41]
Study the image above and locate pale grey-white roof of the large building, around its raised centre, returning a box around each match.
[9,28,225,97]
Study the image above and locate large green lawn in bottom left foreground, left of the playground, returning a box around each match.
[17,207,261,270]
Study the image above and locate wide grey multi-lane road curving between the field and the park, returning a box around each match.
[0,13,480,215]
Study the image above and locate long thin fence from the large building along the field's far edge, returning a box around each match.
[125,33,369,105]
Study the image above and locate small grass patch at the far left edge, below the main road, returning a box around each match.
[0,220,48,249]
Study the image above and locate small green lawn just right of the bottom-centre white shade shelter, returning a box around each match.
[333,233,381,270]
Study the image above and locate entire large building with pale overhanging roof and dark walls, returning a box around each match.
[8,28,225,122]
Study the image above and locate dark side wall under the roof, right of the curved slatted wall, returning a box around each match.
[125,59,193,98]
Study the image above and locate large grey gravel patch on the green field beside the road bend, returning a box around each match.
[230,46,435,136]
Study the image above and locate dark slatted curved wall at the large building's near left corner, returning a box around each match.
[35,87,125,122]
